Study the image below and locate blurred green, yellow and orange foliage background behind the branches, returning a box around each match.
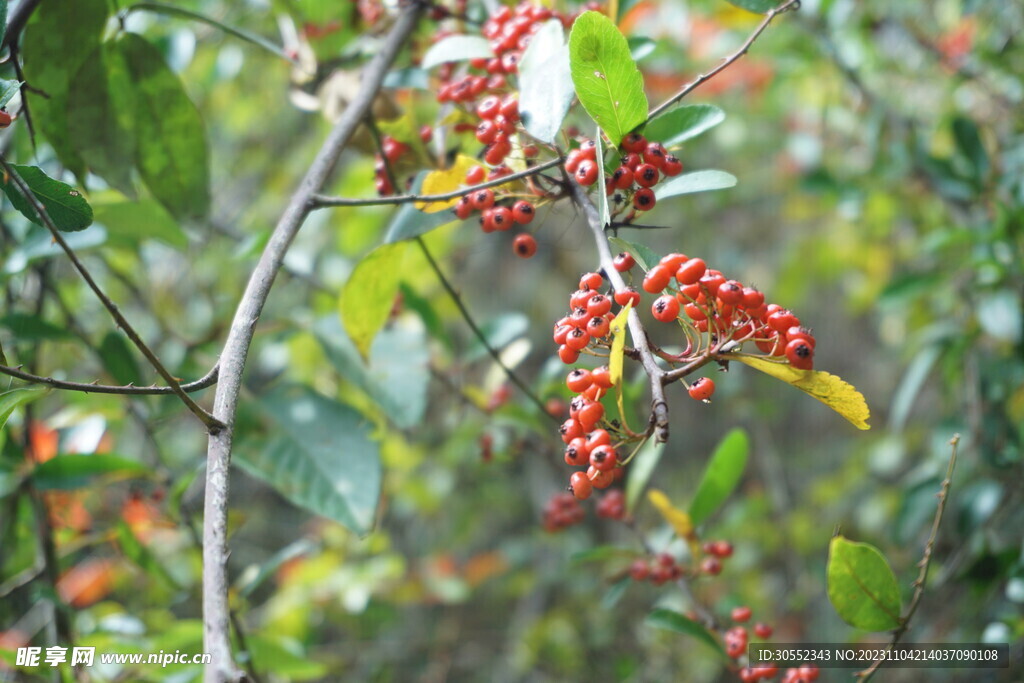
[0,0,1024,681]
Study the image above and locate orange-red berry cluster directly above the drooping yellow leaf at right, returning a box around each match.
[642,254,815,370]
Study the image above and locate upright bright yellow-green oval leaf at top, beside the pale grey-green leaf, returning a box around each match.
[569,11,647,145]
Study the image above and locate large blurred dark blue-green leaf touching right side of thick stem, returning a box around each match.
[236,386,381,535]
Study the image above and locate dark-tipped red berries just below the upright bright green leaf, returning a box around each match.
[565,133,683,213]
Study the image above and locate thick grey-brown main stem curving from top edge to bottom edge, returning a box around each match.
[203,2,423,683]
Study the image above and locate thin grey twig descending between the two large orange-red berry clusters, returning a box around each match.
[568,181,669,443]
